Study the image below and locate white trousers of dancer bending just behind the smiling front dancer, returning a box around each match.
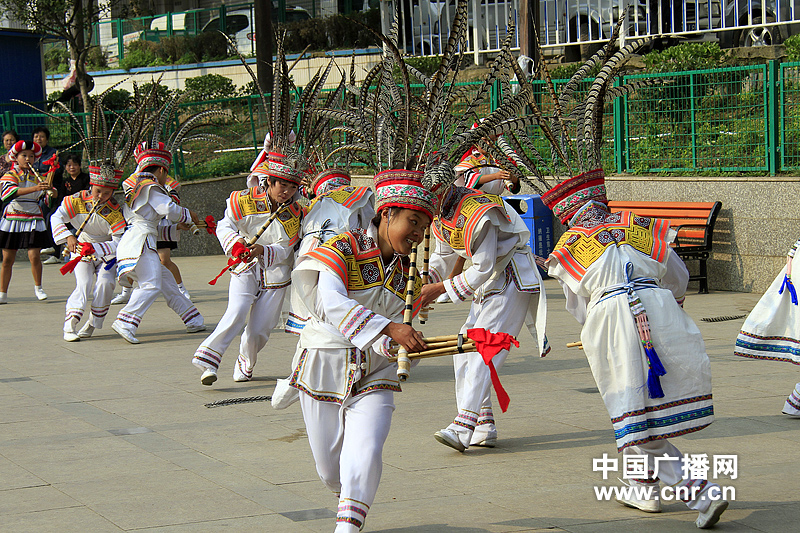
[447,282,539,446]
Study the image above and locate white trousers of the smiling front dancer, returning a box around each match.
[300,390,394,532]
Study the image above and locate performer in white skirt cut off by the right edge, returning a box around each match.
[733,240,800,418]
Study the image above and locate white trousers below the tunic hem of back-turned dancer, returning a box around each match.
[622,439,720,513]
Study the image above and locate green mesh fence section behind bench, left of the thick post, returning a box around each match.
[619,65,771,172]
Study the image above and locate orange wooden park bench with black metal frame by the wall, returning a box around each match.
[608,201,722,294]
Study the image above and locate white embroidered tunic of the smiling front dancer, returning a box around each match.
[290,224,421,403]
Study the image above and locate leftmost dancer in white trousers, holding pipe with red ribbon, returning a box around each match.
[50,175,125,342]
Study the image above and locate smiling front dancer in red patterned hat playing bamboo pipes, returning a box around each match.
[291,170,435,533]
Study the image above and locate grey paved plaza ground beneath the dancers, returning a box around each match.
[0,256,800,533]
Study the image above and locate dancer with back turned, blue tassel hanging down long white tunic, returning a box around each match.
[542,169,728,528]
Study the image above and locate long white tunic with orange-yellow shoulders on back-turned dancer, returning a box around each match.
[548,210,714,450]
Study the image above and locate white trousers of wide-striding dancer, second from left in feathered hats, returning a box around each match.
[117,248,203,333]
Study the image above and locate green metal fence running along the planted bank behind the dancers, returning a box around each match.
[9,61,800,179]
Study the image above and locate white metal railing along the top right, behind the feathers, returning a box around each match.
[394,0,800,64]
